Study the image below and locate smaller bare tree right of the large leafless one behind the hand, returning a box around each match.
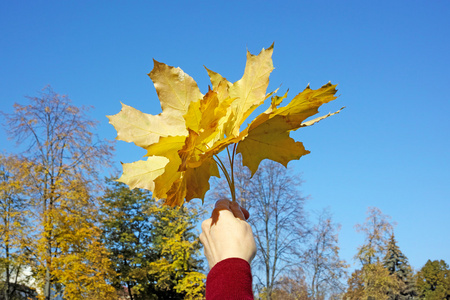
[301,210,348,300]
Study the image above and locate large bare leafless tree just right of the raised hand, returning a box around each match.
[213,156,307,300]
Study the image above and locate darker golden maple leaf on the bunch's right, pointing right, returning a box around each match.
[237,83,346,175]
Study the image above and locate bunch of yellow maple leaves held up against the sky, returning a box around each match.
[108,45,340,206]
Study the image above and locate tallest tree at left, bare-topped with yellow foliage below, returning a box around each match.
[2,87,113,300]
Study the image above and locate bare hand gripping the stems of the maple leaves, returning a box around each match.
[200,199,256,269]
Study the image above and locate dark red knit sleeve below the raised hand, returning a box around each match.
[206,258,253,300]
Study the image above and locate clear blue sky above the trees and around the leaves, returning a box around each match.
[0,1,450,269]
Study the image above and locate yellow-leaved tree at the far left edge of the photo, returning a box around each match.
[0,154,32,300]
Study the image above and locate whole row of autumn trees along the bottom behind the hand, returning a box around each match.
[0,88,450,300]
